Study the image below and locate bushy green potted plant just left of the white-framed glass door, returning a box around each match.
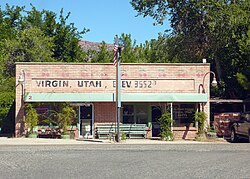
[58,105,76,139]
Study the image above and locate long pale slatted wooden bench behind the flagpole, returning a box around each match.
[96,123,147,139]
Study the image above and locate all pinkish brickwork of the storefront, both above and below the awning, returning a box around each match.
[15,63,210,136]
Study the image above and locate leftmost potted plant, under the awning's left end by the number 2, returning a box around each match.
[24,104,38,138]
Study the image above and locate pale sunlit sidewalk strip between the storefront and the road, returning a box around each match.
[0,137,227,146]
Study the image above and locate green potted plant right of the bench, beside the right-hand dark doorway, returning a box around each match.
[158,112,174,140]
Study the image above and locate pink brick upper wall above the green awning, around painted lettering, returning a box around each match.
[16,63,210,93]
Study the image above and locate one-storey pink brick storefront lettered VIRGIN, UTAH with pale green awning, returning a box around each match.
[15,63,210,138]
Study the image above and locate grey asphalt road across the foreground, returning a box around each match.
[0,143,250,179]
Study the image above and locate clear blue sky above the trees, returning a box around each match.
[0,0,170,44]
